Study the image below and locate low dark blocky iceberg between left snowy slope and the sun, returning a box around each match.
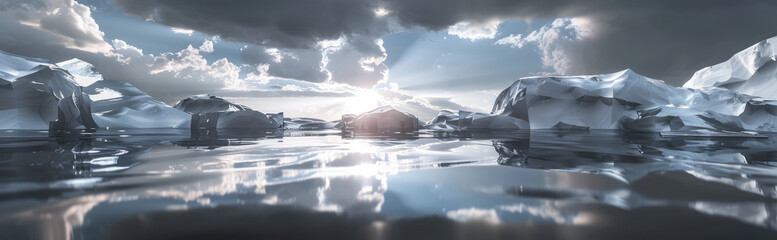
[175,95,283,130]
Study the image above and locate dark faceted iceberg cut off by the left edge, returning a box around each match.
[0,51,97,131]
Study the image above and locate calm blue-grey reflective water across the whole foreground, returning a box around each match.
[0,130,777,239]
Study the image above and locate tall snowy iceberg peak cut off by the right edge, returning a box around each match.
[683,37,777,99]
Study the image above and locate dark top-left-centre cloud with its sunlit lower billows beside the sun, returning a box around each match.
[113,0,390,88]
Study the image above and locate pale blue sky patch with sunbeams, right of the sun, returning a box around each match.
[383,20,552,94]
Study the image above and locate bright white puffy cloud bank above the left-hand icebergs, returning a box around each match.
[98,39,242,100]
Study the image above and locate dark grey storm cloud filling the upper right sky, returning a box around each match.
[384,0,777,85]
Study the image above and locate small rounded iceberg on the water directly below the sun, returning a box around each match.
[341,106,420,133]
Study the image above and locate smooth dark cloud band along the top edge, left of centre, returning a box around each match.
[114,0,387,48]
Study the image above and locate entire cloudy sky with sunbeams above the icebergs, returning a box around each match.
[0,0,777,120]
